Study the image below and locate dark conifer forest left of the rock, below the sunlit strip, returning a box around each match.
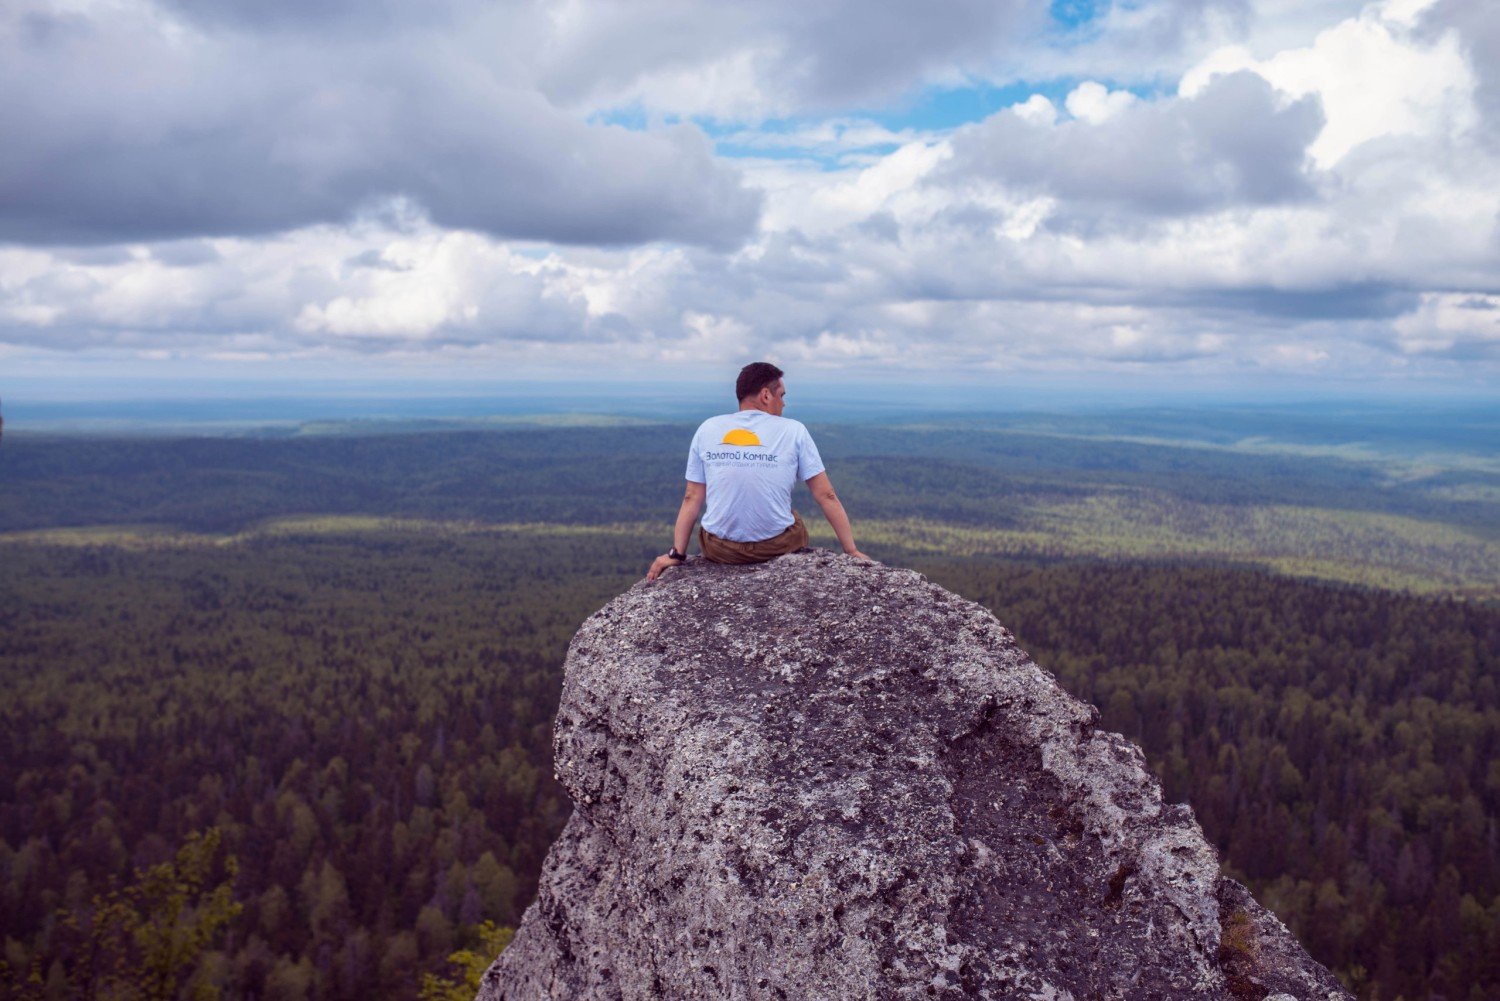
[0,528,639,998]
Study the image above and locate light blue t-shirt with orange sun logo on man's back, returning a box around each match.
[687,410,824,542]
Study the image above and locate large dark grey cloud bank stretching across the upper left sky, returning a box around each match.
[0,3,759,248]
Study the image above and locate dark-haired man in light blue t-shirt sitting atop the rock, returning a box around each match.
[647,362,869,581]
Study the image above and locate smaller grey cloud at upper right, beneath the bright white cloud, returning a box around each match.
[941,72,1323,216]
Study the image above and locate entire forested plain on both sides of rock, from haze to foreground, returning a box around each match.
[0,429,1500,999]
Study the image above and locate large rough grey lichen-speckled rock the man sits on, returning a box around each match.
[479,551,1349,1001]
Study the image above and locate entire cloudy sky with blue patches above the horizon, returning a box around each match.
[0,0,1500,393]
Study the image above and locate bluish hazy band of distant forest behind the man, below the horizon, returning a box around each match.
[0,423,1500,537]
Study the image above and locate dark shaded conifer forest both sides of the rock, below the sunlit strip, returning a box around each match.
[0,531,1500,998]
